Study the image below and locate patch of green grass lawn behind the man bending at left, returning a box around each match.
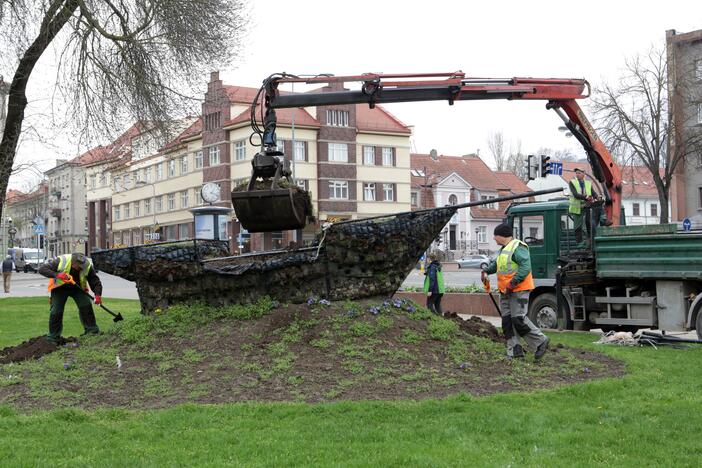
[0,296,141,348]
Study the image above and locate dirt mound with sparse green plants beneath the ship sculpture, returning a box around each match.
[0,301,624,410]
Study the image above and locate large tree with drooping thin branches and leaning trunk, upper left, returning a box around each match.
[0,0,248,207]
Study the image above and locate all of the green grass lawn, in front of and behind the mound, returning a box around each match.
[0,298,702,467]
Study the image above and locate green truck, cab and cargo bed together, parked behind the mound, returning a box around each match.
[506,199,702,339]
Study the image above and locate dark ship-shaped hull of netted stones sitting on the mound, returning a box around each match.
[91,207,456,314]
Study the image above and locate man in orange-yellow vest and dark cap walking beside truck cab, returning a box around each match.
[481,224,549,360]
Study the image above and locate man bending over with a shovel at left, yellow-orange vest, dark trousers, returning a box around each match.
[39,252,102,344]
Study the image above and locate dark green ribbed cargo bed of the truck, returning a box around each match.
[595,224,702,280]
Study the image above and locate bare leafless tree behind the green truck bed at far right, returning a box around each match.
[593,47,702,223]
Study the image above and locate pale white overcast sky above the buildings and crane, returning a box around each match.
[6,0,702,188]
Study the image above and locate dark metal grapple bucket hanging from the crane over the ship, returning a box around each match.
[232,187,311,232]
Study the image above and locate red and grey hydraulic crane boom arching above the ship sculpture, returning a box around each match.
[235,72,621,231]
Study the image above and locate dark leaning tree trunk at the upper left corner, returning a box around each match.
[0,0,78,210]
